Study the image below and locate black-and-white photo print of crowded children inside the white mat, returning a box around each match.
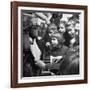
[21,10,80,77]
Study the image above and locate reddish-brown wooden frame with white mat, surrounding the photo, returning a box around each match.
[11,1,88,88]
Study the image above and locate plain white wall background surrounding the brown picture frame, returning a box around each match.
[0,0,90,90]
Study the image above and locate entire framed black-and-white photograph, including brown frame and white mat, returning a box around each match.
[12,2,87,86]
